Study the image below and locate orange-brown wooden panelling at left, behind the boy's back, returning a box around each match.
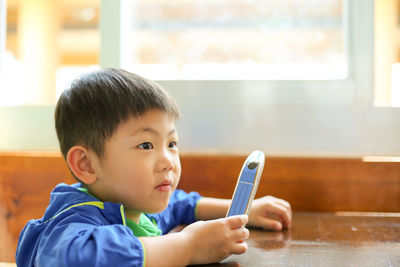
[0,153,74,262]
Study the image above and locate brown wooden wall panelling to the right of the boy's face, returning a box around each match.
[180,155,400,212]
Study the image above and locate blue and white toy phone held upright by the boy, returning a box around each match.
[226,151,265,217]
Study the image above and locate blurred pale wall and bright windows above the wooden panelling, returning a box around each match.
[0,0,400,157]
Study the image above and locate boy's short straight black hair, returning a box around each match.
[55,68,180,158]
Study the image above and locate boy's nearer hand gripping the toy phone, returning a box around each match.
[181,215,249,264]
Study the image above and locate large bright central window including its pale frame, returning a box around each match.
[101,0,373,108]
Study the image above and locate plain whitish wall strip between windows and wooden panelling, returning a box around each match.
[0,102,400,156]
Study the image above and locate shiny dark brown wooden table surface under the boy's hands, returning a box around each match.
[196,212,400,267]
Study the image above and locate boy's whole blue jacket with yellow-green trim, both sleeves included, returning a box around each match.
[16,184,200,267]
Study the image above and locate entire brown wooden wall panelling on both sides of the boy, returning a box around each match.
[0,153,400,262]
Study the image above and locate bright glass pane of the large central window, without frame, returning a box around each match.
[122,0,347,80]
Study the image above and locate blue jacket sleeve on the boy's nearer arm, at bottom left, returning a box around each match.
[35,214,144,267]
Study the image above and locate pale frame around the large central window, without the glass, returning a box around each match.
[100,0,374,106]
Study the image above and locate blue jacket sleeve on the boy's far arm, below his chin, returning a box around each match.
[148,189,201,234]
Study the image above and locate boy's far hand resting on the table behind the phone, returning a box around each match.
[249,196,292,231]
